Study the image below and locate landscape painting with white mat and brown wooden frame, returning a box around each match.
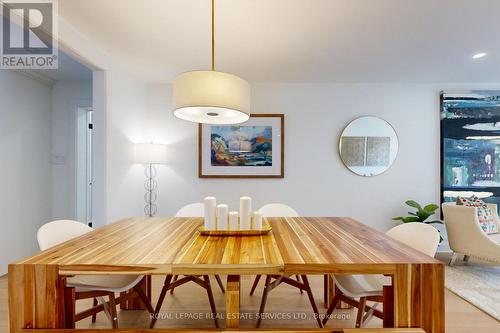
[198,114,285,178]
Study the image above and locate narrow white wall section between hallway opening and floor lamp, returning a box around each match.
[106,70,147,223]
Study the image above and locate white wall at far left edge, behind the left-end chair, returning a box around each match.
[0,70,51,275]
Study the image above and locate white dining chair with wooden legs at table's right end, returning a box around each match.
[323,222,440,328]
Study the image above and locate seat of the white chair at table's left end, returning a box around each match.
[67,275,143,293]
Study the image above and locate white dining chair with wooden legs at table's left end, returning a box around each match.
[37,220,154,328]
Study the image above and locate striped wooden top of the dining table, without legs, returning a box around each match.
[16,217,440,275]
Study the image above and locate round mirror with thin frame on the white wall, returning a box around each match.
[339,116,398,177]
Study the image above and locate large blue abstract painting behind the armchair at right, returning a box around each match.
[441,91,500,203]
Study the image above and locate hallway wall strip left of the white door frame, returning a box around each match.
[52,80,92,219]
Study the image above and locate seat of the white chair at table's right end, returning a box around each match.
[335,274,391,298]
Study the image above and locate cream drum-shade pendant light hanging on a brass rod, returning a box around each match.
[173,0,250,124]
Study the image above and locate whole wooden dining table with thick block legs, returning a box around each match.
[8,217,445,333]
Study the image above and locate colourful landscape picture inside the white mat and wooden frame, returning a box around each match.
[210,126,273,166]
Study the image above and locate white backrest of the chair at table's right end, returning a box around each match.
[386,222,439,257]
